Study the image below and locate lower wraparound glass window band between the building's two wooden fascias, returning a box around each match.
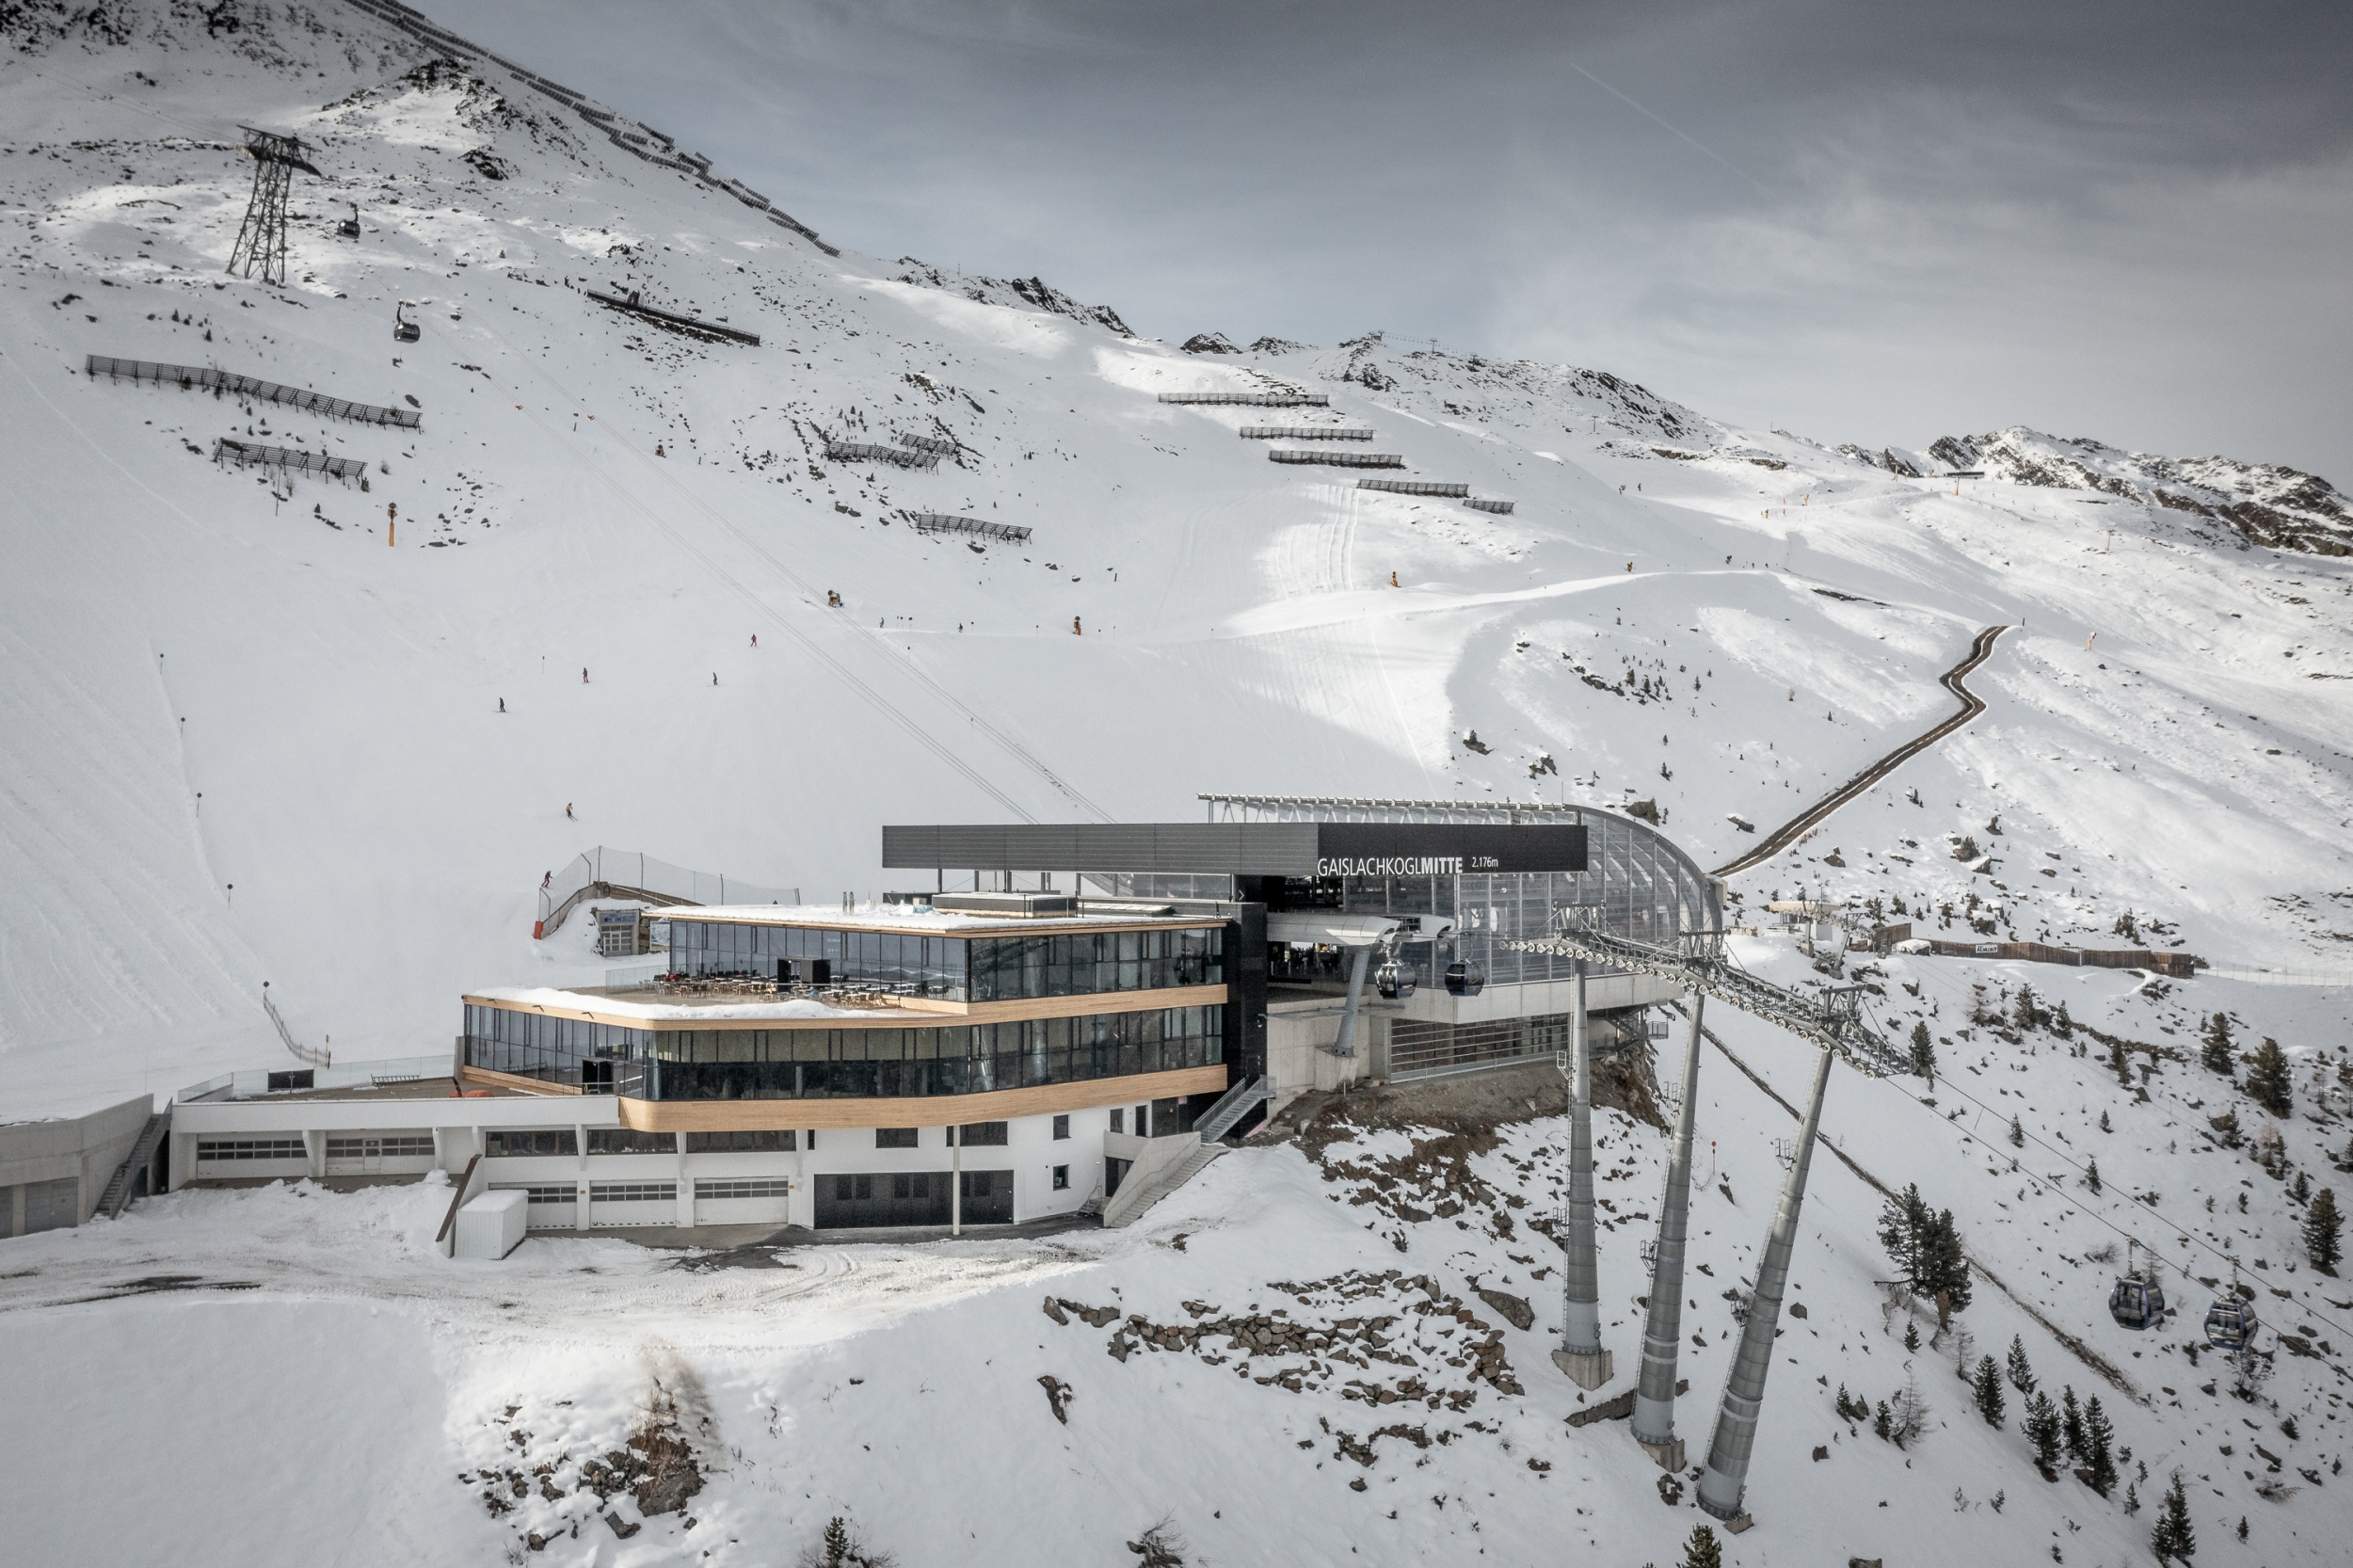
[466,1002,1226,1099]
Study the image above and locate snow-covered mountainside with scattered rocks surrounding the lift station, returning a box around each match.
[0,3,2353,1563]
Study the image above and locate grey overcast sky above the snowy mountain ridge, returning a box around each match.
[424,0,2353,475]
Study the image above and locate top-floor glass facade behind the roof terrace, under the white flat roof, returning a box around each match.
[668,919,1224,1000]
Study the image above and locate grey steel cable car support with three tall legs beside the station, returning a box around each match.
[1504,906,1906,1530]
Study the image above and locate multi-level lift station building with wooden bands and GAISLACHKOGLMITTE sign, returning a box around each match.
[168,796,1721,1231]
